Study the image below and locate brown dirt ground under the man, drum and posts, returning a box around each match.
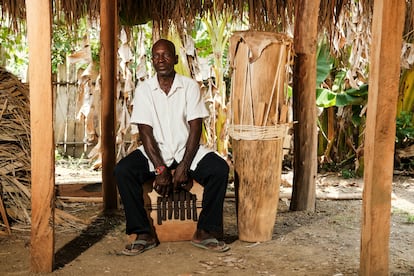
[0,169,414,276]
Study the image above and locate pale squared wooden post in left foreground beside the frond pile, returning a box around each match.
[26,0,55,272]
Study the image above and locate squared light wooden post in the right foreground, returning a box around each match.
[360,0,405,275]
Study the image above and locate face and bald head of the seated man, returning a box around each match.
[152,41,178,77]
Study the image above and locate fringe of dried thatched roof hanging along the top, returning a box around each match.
[0,0,372,30]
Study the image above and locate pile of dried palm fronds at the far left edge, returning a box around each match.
[0,68,31,223]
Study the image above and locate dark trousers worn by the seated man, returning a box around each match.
[114,150,229,235]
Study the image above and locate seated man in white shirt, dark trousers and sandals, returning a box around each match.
[115,39,230,255]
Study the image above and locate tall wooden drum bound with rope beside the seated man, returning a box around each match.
[229,31,292,242]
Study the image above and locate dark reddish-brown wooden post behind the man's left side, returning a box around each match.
[100,0,118,210]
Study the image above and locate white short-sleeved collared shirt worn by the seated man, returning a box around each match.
[131,74,212,171]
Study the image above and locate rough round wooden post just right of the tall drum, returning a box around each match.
[290,0,320,211]
